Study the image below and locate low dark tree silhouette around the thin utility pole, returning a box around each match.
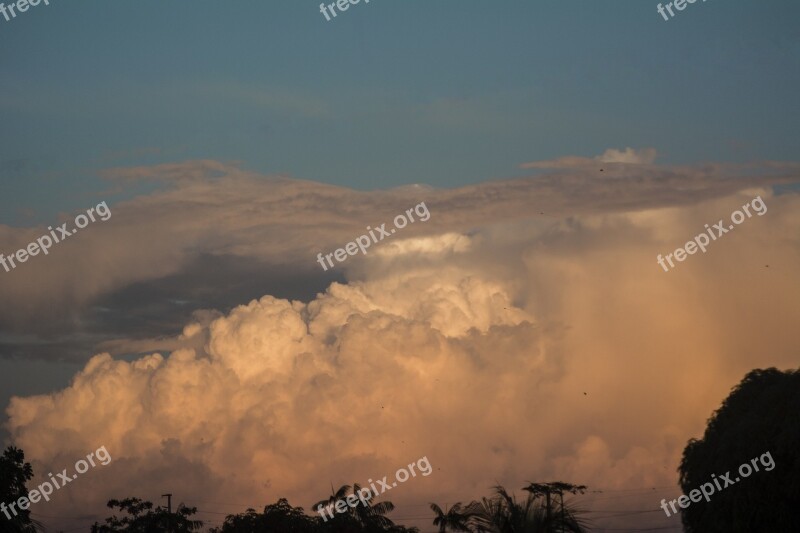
[91,498,203,533]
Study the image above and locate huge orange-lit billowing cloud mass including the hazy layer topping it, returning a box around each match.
[1,160,800,528]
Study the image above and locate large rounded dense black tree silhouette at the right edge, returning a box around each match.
[678,368,800,533]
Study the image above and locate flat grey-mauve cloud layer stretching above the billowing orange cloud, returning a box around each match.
[0,155,800,361]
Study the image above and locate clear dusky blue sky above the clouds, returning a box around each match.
[0,0,800,225]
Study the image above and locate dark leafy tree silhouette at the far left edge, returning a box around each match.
[0,446,44,533]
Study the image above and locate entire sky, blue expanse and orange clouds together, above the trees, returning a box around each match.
[0,0,800,532]
